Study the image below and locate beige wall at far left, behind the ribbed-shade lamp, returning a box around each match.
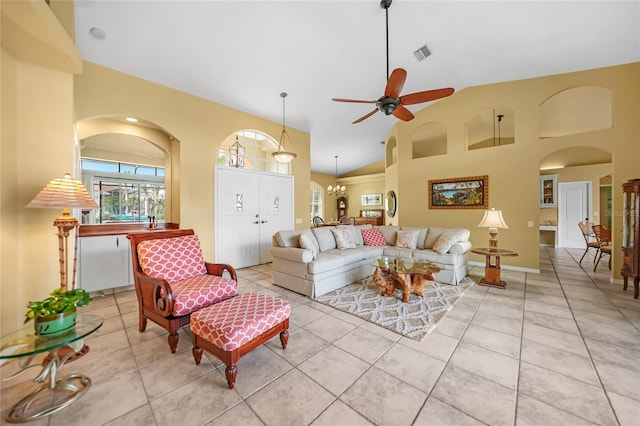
[0,2,81,335]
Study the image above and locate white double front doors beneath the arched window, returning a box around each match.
[214,166,293,268]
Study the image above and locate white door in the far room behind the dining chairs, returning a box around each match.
[556,181,591,248]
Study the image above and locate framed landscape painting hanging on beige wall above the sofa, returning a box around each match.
[429,176,489,209]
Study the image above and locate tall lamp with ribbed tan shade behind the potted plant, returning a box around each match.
[27,173,99,291]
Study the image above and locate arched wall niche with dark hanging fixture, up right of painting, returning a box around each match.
[465,106,515,150]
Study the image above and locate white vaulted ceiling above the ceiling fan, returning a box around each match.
[75,0,640,174]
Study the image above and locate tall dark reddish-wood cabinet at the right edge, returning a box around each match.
[621,179,640,299]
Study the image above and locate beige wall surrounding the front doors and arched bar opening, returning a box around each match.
[75,62,310,259]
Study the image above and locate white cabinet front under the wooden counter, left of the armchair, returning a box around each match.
[78,234,133,291]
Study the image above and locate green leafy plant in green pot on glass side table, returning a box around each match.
[24,287,99,336]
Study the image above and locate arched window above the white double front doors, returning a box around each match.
[218,129,291,175]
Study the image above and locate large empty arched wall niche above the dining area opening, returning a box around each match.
[538,86,613,139]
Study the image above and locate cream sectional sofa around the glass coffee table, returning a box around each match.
[271,224,471,298]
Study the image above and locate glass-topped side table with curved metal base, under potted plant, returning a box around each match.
[0,315,102,423]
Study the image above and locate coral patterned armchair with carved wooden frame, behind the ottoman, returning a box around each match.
[127,229,238,353]
